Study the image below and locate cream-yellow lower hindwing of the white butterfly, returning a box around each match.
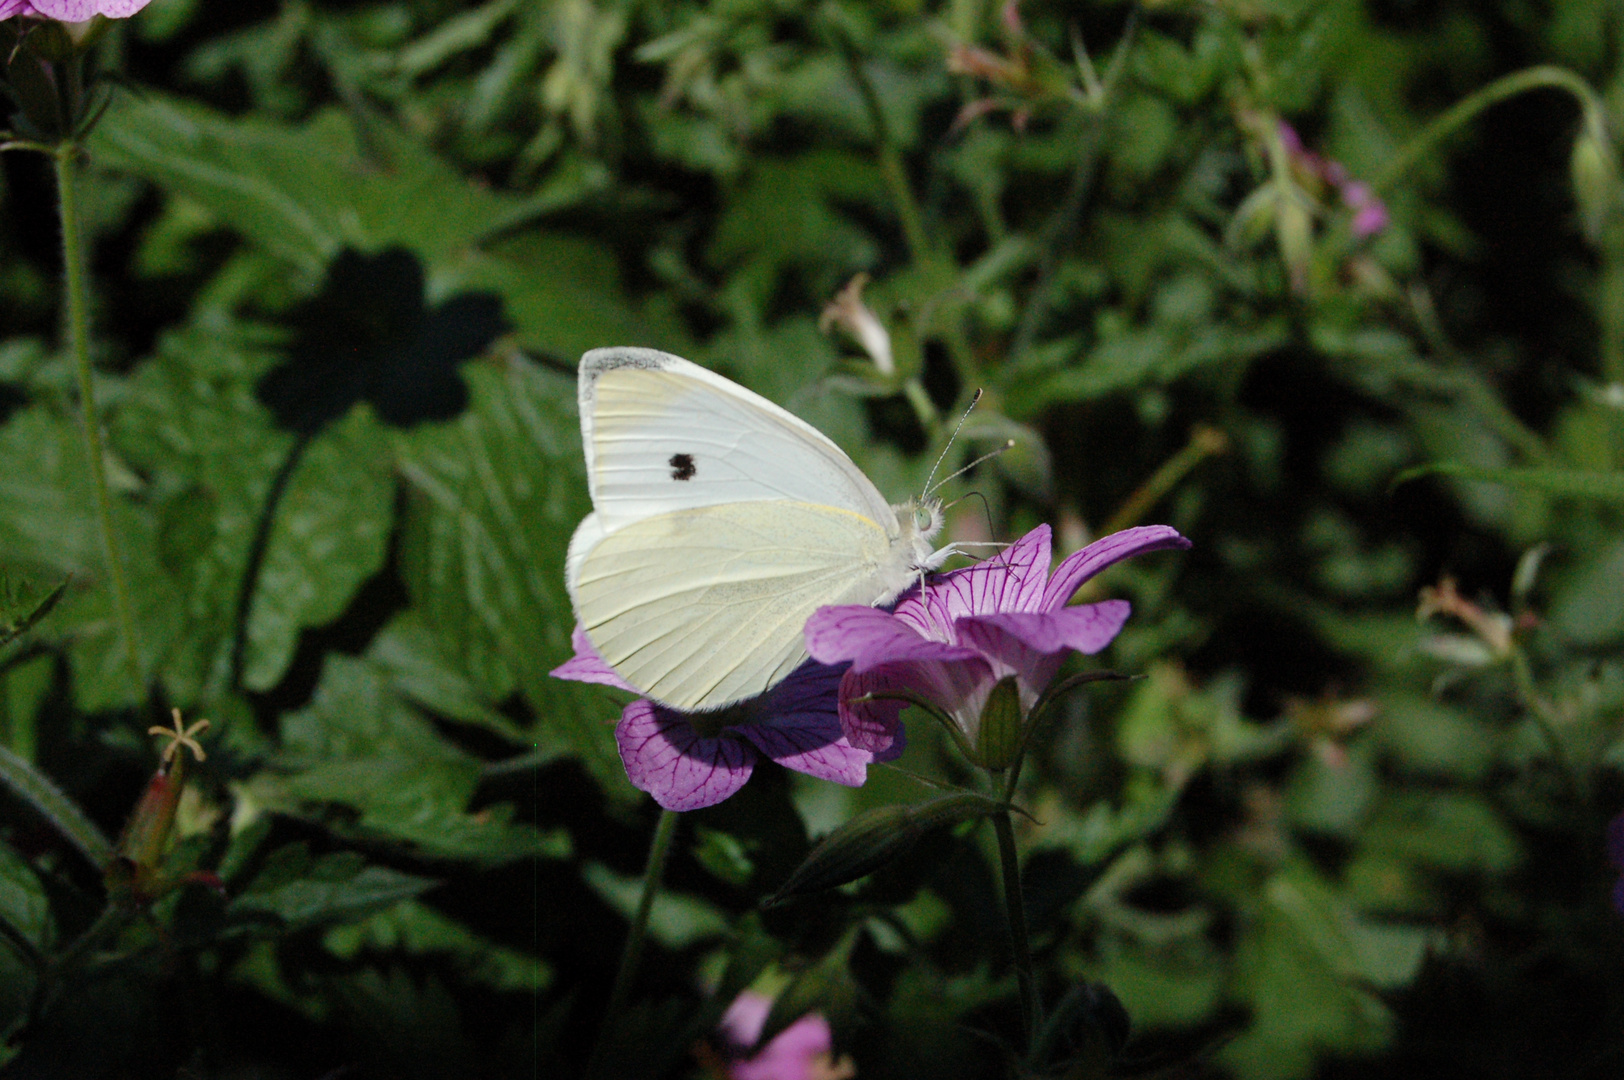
[572,500,892,711]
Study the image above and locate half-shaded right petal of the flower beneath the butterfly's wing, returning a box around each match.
[731,663,874,788]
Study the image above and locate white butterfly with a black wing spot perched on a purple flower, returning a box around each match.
[565,348,952,711]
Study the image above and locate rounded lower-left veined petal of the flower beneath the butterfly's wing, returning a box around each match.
[614,700,755,810]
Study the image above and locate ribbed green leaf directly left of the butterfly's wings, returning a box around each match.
[401,364,635,799]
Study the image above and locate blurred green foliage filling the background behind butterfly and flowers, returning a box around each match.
[0,0,1624,1080]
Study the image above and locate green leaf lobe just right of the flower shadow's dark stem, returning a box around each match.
[242,411,395,690]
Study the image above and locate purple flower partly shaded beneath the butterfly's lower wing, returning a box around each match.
[552,627,901,810]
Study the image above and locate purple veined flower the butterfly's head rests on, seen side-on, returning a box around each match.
[806,525,1190,754]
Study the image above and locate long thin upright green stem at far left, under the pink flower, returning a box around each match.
[52,141,141,698]
